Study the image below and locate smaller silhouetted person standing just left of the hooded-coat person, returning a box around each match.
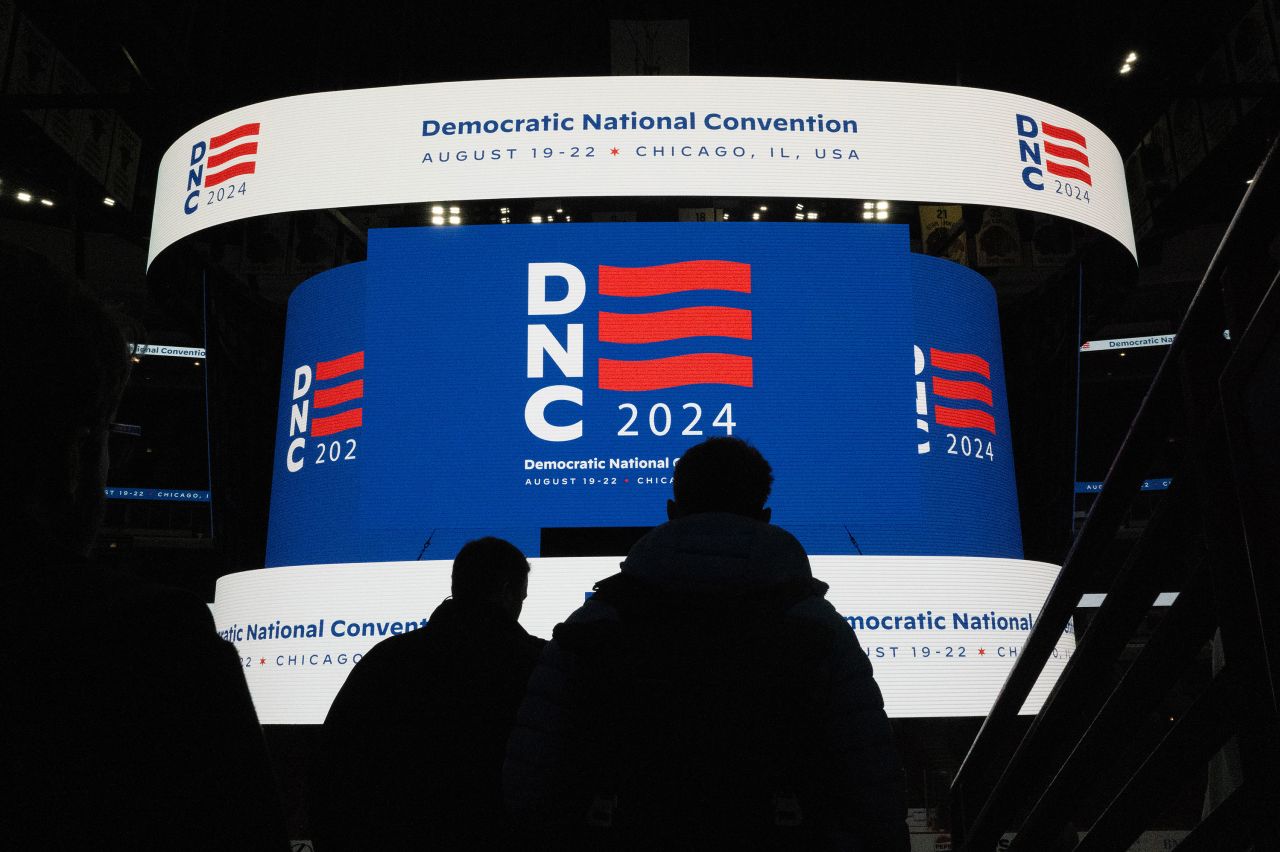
[310,539,545,852]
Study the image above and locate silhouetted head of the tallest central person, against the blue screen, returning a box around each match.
[672,438,773,517]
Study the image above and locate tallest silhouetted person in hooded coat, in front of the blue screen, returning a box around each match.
[504,439,908,852]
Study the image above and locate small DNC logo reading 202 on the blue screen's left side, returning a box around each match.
[284,349,365,473]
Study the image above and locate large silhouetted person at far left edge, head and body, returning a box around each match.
[0,247,288,851]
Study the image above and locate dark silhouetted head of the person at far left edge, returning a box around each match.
[0,244,129,555]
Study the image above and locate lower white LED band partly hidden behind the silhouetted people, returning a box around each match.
[214,556,1075,724]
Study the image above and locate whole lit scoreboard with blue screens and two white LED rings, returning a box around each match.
[151,77,1133,724]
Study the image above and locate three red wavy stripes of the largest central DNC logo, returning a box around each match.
[596,260,754,391]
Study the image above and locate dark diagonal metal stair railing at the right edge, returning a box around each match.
[951,134,1280,852]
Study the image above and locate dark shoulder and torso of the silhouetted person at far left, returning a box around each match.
[0,554,287,849]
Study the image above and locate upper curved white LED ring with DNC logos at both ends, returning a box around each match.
[147,77,1135,265]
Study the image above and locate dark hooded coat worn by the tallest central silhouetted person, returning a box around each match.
[504,513,909,852]
